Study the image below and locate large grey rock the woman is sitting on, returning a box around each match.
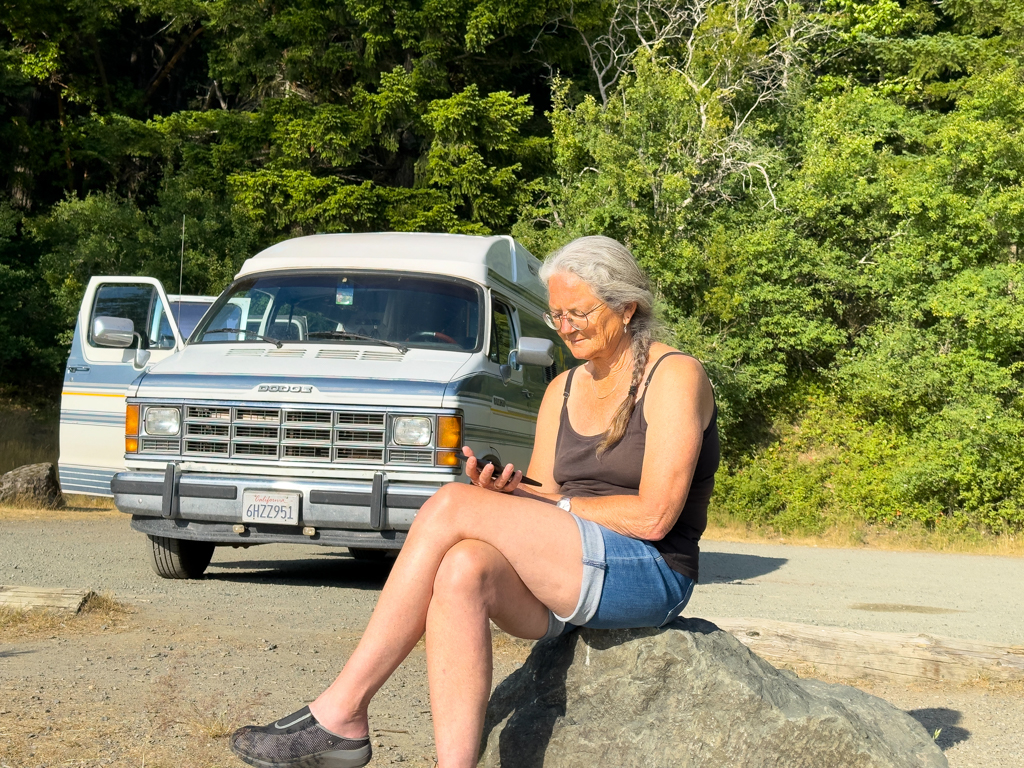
[480,618,947,768]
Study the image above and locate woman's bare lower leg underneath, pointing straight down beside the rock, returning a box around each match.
[427,540,548,768]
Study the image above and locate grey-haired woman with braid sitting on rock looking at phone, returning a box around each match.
[231,237,719,768]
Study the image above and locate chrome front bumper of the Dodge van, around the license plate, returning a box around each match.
[111,464,440,548]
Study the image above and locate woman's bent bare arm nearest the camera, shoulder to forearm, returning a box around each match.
[569,355,715,542]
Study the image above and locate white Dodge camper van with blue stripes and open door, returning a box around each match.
[59,233,573,579]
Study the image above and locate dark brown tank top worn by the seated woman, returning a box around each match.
[554,352,721,581]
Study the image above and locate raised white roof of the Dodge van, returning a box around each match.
[236,232,547,302]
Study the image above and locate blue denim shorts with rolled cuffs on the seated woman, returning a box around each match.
[542,515,693,639]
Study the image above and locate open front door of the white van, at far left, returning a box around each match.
[58,276,182,496]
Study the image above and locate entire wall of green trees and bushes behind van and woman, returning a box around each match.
[0,0,1024,531]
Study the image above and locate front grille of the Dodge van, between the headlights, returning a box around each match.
[139,404,452,467]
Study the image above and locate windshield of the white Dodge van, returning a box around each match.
[191,272,482,351]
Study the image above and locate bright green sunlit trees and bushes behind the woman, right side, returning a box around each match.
[516,3,1024,531]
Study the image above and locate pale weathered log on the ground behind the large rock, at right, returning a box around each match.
[708,618,1024,682]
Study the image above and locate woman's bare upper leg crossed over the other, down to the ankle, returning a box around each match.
[310,484,583,738]
